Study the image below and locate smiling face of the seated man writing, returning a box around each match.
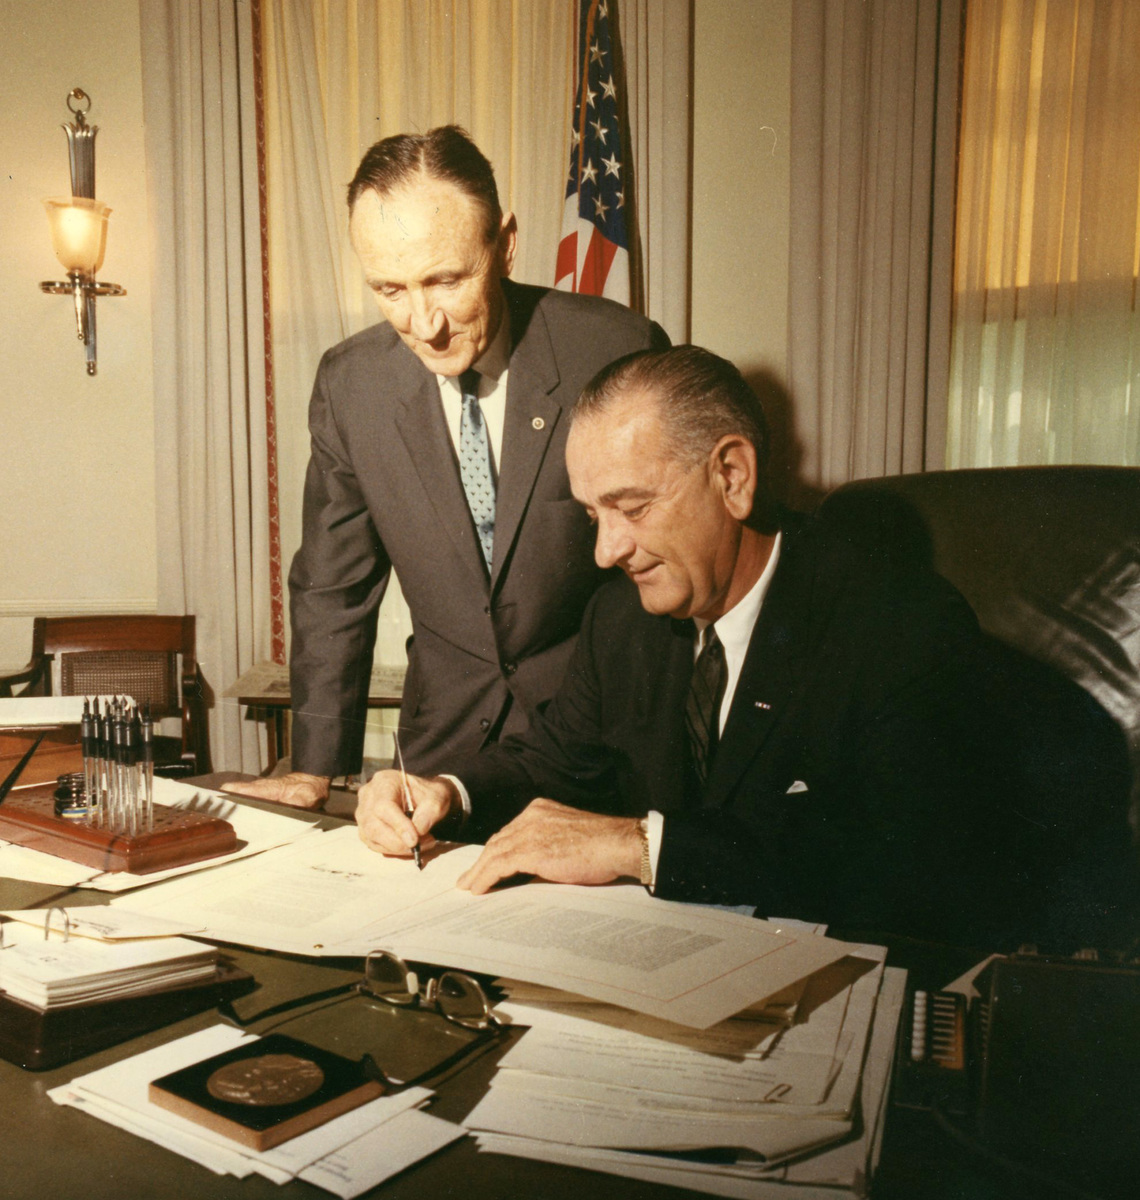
[566,394,742,620]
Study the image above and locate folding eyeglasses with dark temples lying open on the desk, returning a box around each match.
[218,950,503,1087]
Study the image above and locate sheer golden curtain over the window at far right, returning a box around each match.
[949,0,1140,467]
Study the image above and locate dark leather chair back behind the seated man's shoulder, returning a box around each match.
[824,467,1140,796]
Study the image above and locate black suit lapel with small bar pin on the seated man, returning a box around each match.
[703,529,817,808]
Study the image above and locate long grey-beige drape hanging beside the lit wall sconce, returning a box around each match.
[140,0,270,772]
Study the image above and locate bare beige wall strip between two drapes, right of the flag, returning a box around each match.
[692,0,792,377]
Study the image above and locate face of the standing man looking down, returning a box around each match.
[348,174,516,376]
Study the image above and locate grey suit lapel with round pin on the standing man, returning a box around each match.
[491,280,563,587]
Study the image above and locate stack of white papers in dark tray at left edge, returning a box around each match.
[0,925,217,1009]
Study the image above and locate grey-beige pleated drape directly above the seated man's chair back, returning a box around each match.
[788,0,961,490]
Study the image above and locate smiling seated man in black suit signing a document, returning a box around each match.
[358,347,1132,942]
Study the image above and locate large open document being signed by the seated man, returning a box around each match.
[114,826,848,1028]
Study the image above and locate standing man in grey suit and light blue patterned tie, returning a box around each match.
[228,126,667,808]
